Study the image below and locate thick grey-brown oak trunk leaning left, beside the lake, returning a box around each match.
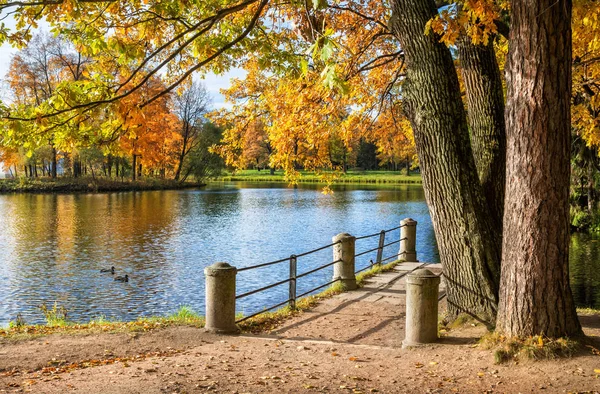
[391,0,501,325]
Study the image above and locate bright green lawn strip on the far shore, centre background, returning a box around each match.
[215,170,422,185]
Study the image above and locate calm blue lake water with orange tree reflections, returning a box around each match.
[0,183,600,325]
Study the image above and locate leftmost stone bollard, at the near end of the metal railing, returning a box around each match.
[204,263,239,334]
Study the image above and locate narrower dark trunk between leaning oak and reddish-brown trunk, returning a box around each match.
[458,36,506,229]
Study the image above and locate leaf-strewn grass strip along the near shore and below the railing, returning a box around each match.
[0,261,400,340]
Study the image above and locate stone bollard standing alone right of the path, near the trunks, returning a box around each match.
[402,269,440,348]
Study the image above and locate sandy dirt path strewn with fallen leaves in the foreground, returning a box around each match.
[0,265,600,394]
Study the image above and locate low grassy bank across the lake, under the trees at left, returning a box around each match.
[0,177,202,193]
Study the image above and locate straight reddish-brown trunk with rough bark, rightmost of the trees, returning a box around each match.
[498,0,581,337]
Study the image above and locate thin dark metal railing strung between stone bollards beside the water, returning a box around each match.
[235,226,406,323]
